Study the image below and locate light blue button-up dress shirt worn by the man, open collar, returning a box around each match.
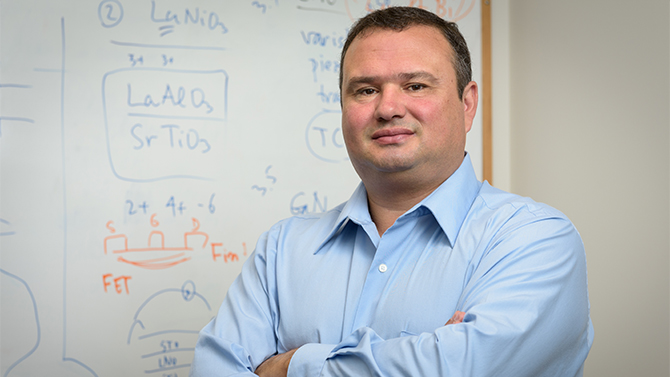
[191,155,593,377]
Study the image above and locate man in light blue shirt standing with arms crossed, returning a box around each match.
[191,8,593,377]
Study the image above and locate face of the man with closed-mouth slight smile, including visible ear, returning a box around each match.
[342,26,477,180]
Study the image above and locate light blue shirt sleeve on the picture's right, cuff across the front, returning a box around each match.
[288,217,593,377]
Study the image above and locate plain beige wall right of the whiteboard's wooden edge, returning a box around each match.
[492,0,670,377]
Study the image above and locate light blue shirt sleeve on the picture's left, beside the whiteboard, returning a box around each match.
[190,229,286,377]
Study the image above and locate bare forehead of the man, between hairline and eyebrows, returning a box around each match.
[342,25,453,80]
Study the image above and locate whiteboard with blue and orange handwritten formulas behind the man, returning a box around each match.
[0,0,482,376]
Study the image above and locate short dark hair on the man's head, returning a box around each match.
[339,7,472,98]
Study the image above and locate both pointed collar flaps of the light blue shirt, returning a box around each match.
[316,153,481,252]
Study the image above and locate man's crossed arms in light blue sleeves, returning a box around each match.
[191,212,593,376]
